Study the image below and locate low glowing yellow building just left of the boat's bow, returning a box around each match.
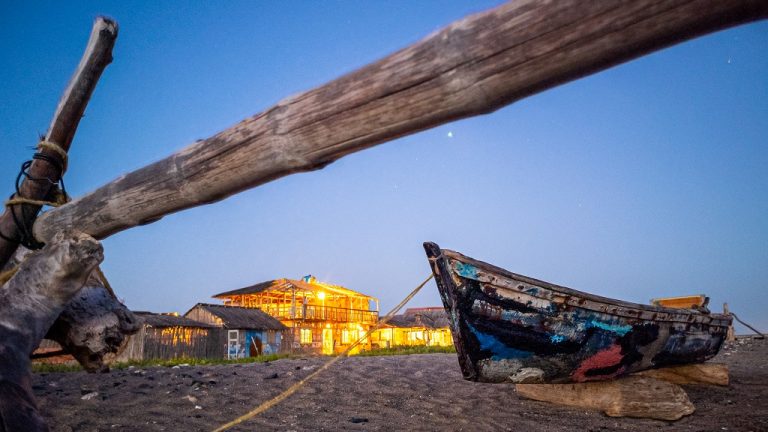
[371,307,453,348]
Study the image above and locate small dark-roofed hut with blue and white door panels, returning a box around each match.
[184,303,291,359]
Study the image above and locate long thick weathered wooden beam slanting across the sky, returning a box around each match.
[34,0,768,241]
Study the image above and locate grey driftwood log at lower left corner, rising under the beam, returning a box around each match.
[0,233,103,431]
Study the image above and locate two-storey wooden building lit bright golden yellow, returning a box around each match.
[213,276,379,354]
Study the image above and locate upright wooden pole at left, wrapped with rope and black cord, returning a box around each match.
[0,17,117,269]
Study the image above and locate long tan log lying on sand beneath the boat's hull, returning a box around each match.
[515,376,695,420]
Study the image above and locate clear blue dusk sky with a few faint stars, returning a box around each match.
[0,0,768,332]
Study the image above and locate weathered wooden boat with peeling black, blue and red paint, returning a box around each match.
[424,243,732,383]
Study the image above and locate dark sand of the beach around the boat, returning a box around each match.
[34,338,768,432]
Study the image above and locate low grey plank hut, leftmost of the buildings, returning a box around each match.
[116,312,221,361]
